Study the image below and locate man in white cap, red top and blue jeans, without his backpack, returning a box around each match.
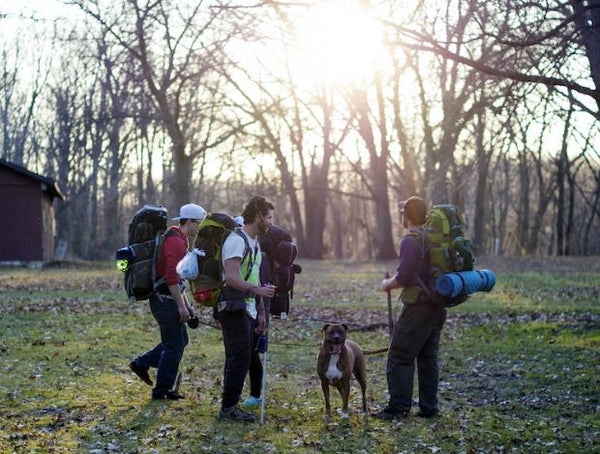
[129,203,206,400]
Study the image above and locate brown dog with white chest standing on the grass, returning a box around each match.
[317,324,367,418]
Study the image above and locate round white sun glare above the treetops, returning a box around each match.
[295,0,383,83]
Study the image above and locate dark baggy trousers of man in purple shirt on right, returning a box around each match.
[387,301,446,414]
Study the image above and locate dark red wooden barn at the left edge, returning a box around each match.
[0,159,64,263]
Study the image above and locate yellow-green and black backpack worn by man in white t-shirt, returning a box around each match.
[190,213,249,307]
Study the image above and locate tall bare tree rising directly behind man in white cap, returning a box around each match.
[70,0,239,205]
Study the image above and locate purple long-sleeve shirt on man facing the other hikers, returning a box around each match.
[396,235,429,287]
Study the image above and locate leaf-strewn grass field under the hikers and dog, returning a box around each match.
[0,258,600,453]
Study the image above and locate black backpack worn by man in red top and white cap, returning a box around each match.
[116,205,169,301]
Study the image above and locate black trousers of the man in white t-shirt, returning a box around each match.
[219,309,253,408]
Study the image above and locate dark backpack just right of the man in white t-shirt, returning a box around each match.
[259,225,302,318]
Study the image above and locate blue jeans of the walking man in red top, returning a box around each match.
[135,295,189,398]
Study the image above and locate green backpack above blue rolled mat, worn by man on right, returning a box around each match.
[400,204,475,307]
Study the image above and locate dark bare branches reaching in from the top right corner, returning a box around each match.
[388,0,600,118]
